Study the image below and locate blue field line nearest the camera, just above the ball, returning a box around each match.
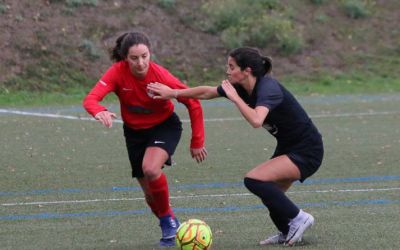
[0,199,400,221]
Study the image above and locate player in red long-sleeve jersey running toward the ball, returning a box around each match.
[83,32,207,247]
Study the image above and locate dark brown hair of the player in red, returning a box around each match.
[111,32,151,62]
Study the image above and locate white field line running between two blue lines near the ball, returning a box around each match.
[1,187,400,207]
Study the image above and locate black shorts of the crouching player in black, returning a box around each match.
[271,133,324,182]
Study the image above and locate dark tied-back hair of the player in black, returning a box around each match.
[229,47,272,77]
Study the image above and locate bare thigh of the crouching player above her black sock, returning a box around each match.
[246,155,300,183]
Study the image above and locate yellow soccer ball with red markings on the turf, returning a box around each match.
[176,219,212,250]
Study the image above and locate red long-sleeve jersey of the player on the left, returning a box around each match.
[83,61,204,148]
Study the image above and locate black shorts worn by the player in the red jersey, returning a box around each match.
[124,113,182,178]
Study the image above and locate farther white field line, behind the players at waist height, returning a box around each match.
[0,109,400,123]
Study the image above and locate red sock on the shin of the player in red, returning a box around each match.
[148,173,175,218]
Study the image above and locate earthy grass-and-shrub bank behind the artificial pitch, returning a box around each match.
[0,0,400,106]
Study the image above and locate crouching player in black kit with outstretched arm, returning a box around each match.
[148,47,324,246]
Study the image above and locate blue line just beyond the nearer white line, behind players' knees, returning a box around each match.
[0,176,400,196]
